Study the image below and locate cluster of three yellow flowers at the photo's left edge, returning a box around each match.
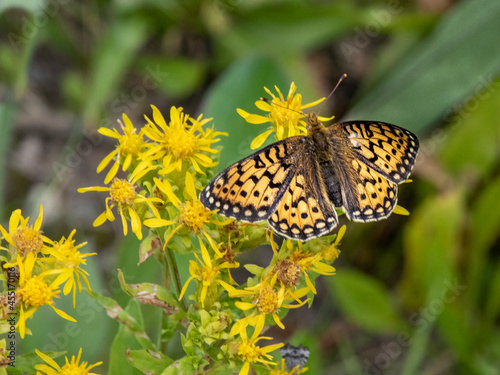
[0,206,95,338]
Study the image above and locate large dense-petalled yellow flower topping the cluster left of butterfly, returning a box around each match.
[139,105,227,175]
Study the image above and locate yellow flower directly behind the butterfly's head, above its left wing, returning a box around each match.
[237,82,333,150]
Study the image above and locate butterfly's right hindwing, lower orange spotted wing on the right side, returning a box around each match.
[342,160,398,222]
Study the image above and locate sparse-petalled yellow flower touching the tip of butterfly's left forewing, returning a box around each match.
[144,172,232,253]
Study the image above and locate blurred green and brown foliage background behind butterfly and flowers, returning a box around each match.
[0,0,500,375]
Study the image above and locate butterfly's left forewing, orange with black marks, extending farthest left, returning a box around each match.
[200,136,306,222]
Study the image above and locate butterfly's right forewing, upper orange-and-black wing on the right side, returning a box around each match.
[340,121,419,184]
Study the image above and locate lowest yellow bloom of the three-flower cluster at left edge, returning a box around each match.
[16,252,76,338]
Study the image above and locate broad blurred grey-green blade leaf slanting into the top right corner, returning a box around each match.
[347,0,500,132]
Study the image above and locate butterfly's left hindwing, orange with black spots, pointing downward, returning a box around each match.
[269,152,338,241]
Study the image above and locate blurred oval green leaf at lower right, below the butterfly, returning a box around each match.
[327,270,406,333]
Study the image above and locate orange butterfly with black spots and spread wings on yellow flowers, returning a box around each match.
[199,113,419,241]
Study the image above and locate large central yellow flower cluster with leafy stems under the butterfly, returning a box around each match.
[71,83,345,375]
